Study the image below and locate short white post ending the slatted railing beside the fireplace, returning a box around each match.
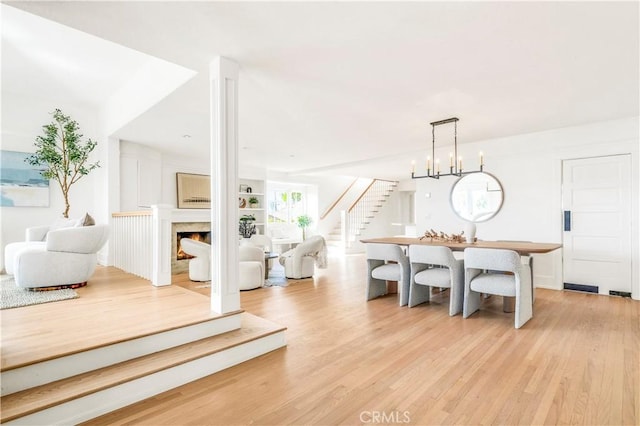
[151,204,171,287]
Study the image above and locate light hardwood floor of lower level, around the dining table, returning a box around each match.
[82,255,640,425]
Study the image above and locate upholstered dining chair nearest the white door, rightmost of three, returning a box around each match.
[463,248,533,328]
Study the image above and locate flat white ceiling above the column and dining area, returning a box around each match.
[2,1,640,179]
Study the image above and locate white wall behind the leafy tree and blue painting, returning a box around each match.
[0,91,103,268]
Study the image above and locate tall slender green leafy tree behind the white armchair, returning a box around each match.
[25,108,100,218]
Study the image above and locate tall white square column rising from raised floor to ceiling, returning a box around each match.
[209,57,240,314]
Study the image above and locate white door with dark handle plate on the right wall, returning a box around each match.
[562,155,631,294]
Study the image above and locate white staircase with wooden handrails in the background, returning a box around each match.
[326,179,398,250]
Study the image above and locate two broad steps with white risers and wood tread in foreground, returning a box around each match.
[0,311,286,424]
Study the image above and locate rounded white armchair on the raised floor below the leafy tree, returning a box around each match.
[5,225,109,288]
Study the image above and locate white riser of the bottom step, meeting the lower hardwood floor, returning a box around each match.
[4,331,286,425]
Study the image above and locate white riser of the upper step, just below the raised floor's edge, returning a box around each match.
[1,314,241,396]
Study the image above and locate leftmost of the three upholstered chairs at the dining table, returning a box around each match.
[366,243,411,306]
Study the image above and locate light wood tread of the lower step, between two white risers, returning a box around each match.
[0,312,286,423]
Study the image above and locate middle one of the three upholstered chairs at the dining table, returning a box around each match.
[409,245,464,316]
